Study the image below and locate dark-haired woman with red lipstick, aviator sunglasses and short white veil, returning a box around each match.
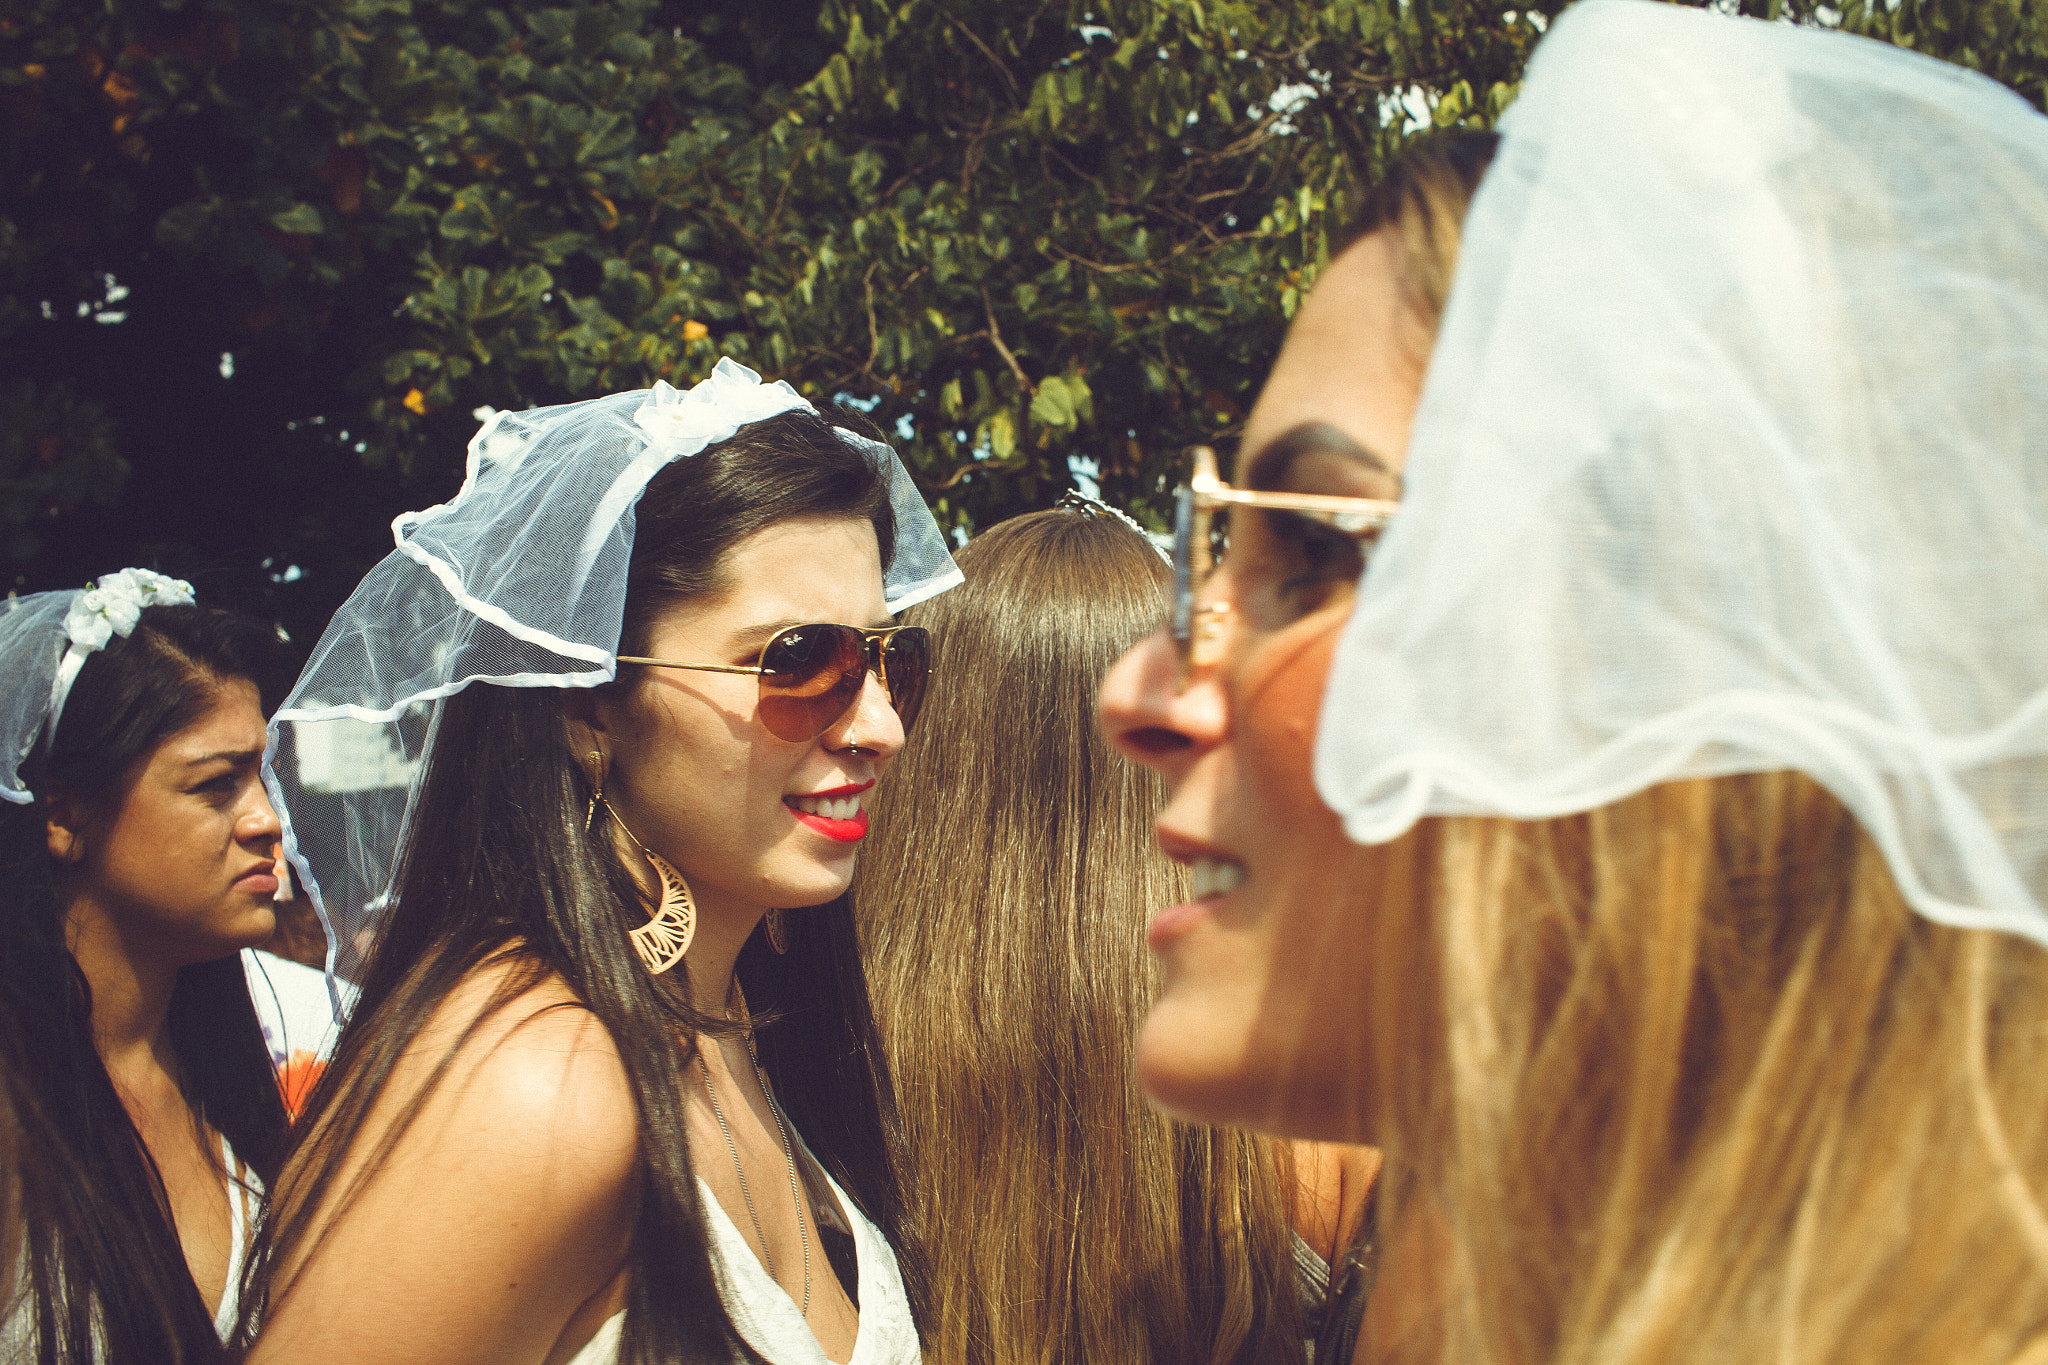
[250,360,958,1365]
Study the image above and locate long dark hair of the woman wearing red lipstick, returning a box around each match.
[244,413,915,1365]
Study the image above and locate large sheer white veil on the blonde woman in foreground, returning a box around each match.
[1315,0,2048,945]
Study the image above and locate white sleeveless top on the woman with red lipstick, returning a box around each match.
[569,1166,924,1365]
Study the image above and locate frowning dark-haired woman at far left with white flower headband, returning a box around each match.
[0,569,285,1361]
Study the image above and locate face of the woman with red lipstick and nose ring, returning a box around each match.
[578,518,903,911]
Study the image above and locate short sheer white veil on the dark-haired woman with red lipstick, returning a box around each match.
[264,360,961,982]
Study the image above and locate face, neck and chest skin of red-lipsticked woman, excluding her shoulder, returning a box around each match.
[578,518,903,1361]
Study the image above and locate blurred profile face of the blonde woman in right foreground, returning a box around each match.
[1102,233,1423,1140]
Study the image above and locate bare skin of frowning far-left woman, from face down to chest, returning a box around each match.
[47,679,279,1312]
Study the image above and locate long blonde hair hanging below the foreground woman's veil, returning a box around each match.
[1358,774,2048,1365]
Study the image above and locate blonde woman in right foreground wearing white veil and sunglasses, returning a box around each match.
[1102,0,2048,1365]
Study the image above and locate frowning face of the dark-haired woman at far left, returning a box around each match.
[49,677,279,966]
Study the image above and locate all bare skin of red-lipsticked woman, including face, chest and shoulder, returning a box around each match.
[250,518,903,1365]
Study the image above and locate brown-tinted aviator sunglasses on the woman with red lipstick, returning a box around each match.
[618,624,932,745]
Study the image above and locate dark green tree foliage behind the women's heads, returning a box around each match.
[0,0,2048,645]
